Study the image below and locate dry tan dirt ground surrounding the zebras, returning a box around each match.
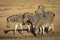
[0,0,60,40]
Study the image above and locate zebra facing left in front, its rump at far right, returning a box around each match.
[24,11,55,34]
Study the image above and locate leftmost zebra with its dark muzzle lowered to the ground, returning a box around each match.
[7,13,36,36]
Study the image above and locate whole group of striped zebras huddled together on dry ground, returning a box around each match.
[7,5,55,36]
